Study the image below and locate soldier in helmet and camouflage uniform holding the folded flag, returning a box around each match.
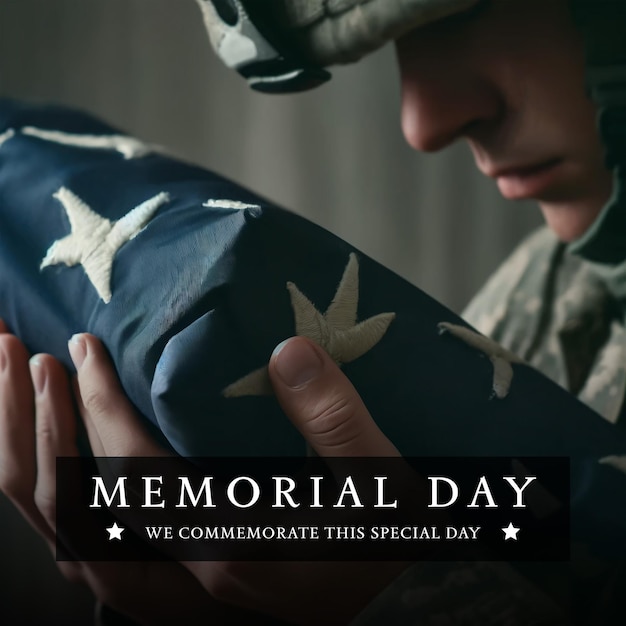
[0,0,626,626]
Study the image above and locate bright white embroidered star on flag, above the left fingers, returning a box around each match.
[40,187,169,304]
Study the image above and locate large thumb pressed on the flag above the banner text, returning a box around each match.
[269,337,399,456]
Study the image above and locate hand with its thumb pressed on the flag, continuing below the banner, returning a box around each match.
[180,337,408,625]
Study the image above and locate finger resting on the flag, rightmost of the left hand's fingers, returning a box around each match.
[69,334,167,457]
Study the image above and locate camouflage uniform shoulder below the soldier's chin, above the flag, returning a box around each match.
[464,228,626,423]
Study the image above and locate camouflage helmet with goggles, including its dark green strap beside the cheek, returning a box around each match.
[197,0,626,264]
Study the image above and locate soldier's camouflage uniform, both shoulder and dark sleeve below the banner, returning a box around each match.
[353,228,626,626]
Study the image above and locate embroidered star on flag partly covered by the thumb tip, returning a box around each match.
[222,253,396,398]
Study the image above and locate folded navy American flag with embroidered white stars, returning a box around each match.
[0,100,626,462]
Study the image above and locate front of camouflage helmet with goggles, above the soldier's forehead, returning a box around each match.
[197,0,480,93]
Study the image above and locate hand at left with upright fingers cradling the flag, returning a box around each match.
[0,321,276,626]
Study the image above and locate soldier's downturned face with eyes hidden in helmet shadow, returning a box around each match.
[396,0,612,241]
